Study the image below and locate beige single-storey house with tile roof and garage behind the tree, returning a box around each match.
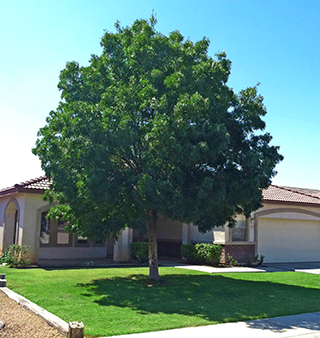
[0,177,320,263]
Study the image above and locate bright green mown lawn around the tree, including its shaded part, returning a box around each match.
[0,267,320,336]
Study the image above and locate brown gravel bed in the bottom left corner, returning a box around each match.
[0,291,65,338]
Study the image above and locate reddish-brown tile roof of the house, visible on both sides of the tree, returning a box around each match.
[0,176,320,206]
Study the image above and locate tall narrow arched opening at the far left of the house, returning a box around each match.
[3,199,21,250]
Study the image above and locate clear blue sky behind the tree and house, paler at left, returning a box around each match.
[0,0,320,189]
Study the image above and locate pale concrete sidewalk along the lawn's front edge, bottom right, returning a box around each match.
[105,312,320,338]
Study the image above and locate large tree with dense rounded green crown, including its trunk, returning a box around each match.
[33,16,282,279]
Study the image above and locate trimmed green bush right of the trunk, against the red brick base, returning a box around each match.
[181,243,222,266]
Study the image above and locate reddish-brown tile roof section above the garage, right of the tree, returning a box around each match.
[262,184,320,205]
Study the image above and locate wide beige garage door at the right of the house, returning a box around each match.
[258,218,320,263]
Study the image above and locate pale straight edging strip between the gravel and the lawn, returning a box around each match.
[0,287,69,336]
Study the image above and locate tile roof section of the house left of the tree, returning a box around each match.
[0,176,51,197]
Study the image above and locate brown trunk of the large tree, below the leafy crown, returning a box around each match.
[147,209,160,281]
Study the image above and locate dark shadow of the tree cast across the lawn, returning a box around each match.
[77,274,320,329]
